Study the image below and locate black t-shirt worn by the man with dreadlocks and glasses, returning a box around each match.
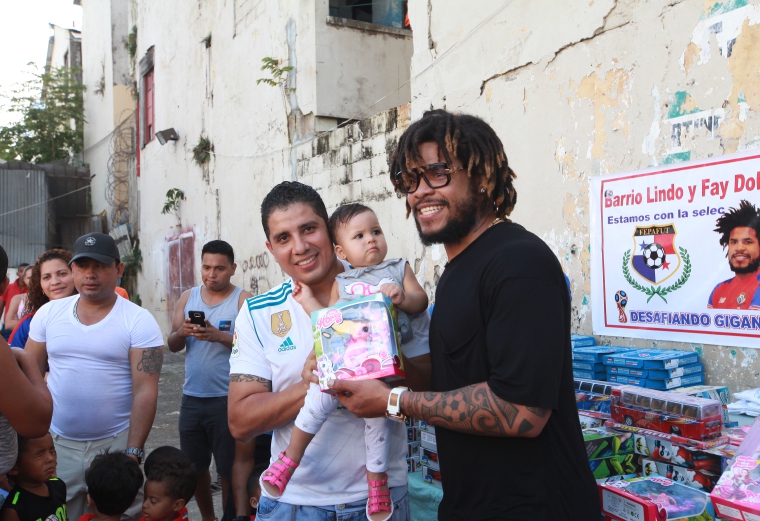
[430,223,601,521]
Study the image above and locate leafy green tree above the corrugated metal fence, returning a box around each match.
[0,67,85,163]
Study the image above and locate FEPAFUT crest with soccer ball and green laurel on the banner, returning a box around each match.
[623,224,691,302]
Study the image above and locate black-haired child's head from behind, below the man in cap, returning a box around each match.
[84,450,143,516]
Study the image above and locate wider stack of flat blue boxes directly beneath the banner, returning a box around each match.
[604,349,704,390]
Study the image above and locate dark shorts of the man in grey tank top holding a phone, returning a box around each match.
[179,394,235,479]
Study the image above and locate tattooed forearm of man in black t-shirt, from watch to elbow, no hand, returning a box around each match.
[401,383,549,436]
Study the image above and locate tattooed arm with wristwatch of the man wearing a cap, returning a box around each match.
[127,346,164,458]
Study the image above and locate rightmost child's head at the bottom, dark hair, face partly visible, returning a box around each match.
[143,449,198,521]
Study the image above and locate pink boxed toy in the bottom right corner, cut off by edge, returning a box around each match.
[710,422,760,521]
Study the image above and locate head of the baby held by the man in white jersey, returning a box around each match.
[328,203,388,268]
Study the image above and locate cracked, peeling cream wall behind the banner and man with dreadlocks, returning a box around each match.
[410,0,760,390]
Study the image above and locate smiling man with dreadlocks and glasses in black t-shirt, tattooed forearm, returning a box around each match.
[333,110,601,521]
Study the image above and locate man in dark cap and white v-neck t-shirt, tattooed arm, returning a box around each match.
[26,233,164,519]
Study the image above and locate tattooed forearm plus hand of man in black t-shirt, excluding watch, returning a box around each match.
[332,380,551,438]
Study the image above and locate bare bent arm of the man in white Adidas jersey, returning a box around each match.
[227,373,309,442]
